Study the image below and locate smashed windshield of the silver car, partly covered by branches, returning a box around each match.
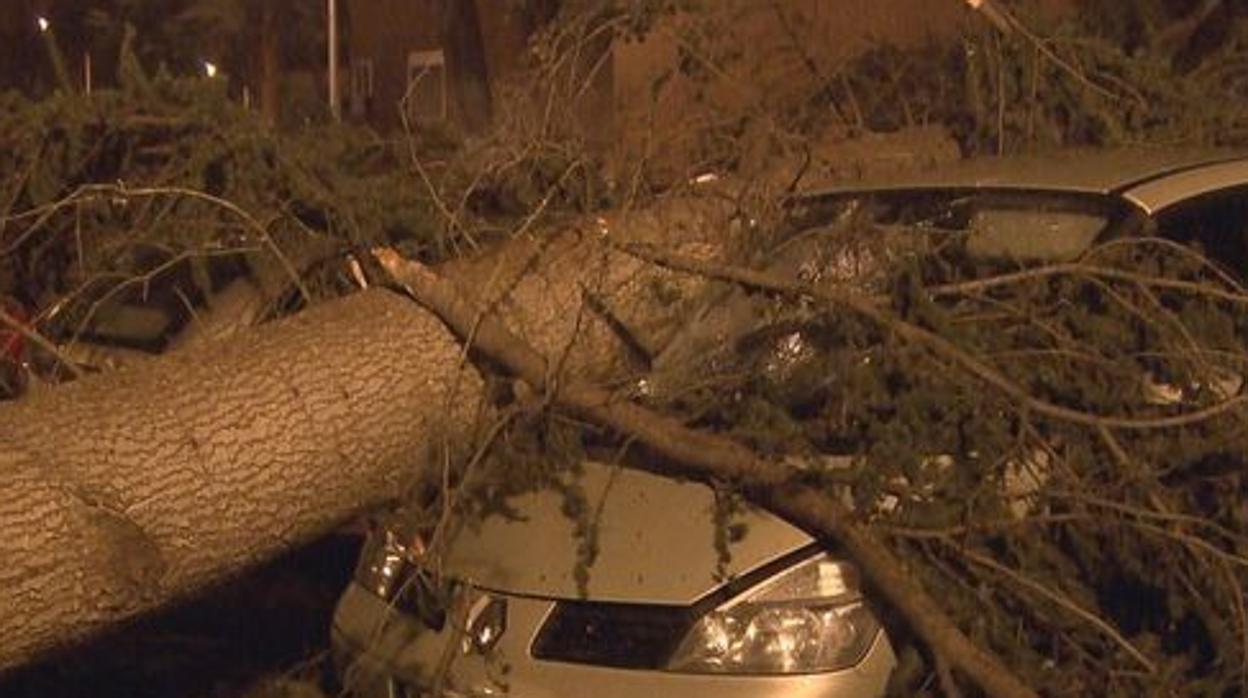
[643,190,1118,442]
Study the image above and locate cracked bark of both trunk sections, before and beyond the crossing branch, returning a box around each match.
[0,194,734,672]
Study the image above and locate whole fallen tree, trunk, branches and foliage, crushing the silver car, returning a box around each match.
[7,2,1248,696]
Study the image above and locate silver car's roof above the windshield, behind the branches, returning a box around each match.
[821,146,1248,212]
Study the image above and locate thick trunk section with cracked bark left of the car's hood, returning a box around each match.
[0,291,482,669]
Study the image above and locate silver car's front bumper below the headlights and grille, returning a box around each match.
[332,584,895,698]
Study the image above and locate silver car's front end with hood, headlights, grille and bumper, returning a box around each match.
[333,462,894,698]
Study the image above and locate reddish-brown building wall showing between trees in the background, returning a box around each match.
[347,0,1077,141]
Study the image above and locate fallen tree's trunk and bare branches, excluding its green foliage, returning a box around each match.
[9,188,1242,696]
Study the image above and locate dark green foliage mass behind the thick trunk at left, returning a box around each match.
[0,71,451,347]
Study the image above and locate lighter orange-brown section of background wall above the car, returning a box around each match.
[613,0,1077,183]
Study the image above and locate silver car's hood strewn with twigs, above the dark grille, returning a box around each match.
[443,462,812,604]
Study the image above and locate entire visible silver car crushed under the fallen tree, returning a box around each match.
[332,149,1248,698]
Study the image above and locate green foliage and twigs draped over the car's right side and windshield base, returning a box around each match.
[661,217,1248,697]
